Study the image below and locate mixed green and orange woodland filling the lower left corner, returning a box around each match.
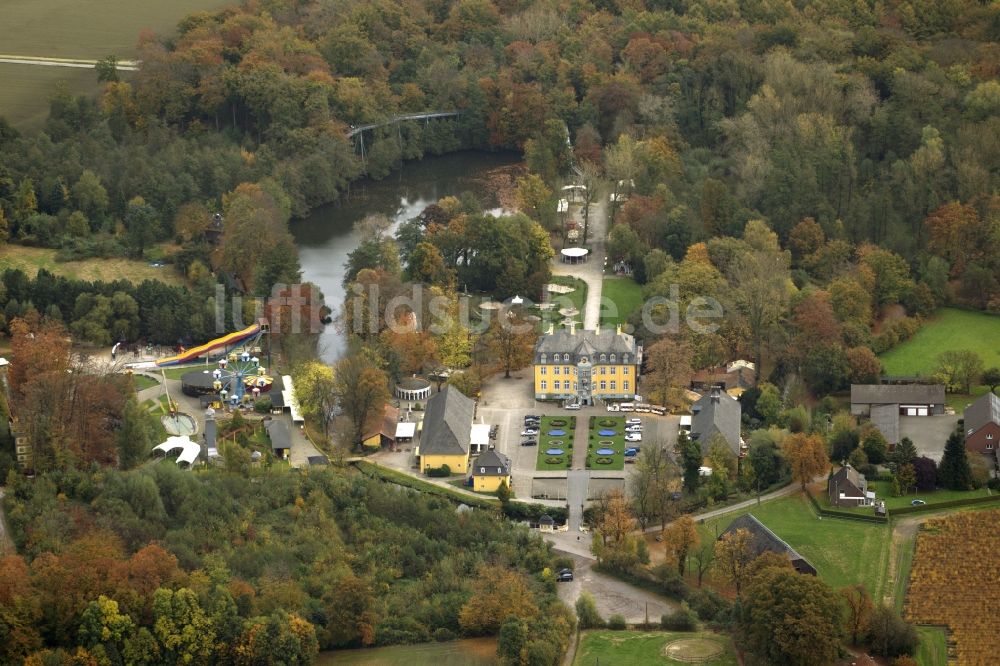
[0,463,575,665]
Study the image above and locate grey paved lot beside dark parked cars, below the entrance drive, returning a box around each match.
[558,556,679,624]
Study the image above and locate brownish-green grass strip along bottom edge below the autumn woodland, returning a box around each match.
[316,638,497,666]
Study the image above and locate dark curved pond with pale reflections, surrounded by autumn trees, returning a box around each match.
[291,151,520,363]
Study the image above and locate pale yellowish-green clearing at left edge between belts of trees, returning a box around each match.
[0,245,183,284]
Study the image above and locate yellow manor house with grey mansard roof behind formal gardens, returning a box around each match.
[534,326,642,405]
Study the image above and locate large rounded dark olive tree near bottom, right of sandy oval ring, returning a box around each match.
[739,567,843,664]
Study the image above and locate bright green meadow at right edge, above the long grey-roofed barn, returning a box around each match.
[880,308,1000,376]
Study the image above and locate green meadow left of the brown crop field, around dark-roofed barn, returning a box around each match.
[696,494,891,599]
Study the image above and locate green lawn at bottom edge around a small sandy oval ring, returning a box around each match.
[573,631,739,666]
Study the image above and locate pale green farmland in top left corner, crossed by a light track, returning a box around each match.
[0,0,229,130]
